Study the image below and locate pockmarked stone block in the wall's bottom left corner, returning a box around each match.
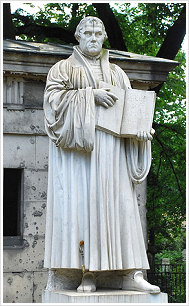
[3,272,33,303]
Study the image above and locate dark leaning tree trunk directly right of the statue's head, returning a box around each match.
[93,3,127,51]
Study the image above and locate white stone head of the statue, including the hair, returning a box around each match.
[75,16,107,56]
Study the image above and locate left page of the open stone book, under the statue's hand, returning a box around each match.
[96,81,125,136]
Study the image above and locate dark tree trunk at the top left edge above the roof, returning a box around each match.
[3,3,15,39]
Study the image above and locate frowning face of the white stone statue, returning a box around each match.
[79,22,104,56]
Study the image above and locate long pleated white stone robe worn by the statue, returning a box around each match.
[44,47,151,271]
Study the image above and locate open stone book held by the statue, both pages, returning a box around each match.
[96,81,156,138]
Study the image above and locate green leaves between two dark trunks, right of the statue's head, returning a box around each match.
[113,3,186,59]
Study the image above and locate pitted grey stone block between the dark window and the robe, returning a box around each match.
[24,169,47,202]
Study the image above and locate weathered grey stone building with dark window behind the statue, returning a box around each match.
[3,40,177,303]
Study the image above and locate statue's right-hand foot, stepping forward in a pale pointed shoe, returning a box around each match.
[122,271,160,293]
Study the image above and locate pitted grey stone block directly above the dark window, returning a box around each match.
[3,135,35,168]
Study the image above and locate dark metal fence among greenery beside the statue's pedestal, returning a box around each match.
[147,264,186,303]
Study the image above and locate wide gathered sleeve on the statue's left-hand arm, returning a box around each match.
[44,61,95,152]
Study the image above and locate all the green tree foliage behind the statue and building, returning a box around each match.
[5,2,186,260]
